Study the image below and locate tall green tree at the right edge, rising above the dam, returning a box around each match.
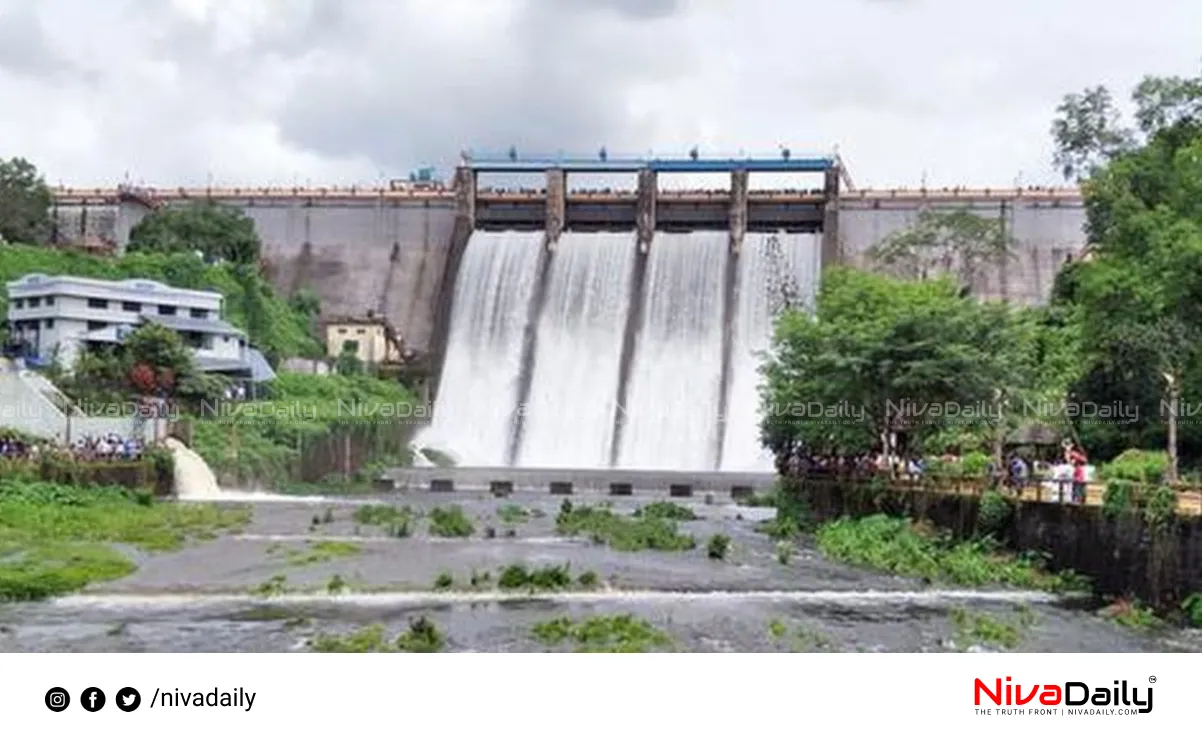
[1053,66,1202,466]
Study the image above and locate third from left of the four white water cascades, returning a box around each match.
[617,232,730,470]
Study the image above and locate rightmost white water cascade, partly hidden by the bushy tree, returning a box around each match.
[721,232,822,471]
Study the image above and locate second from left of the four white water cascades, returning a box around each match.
[517,232,637,468]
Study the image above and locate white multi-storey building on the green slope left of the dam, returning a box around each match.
[7,274,274,380]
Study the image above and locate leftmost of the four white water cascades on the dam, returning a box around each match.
[419,232,543,466]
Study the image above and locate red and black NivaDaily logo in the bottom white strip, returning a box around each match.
[972,676,1156,715]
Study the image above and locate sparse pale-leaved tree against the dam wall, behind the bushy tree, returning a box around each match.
[868,209,1013,289]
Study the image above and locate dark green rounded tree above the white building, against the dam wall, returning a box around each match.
[126,201,261,266]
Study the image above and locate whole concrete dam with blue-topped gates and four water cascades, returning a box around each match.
[46,152,1085,472]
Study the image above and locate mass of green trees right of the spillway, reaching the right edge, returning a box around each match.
[762,65,1202,480]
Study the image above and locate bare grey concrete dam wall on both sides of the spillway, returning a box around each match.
[46,194,1085,351]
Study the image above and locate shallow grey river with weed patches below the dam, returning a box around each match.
[0,493,1200,652]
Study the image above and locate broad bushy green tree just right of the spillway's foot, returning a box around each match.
[761,268,1027,458]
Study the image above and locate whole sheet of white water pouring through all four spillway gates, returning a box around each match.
[419,231,820,471]
